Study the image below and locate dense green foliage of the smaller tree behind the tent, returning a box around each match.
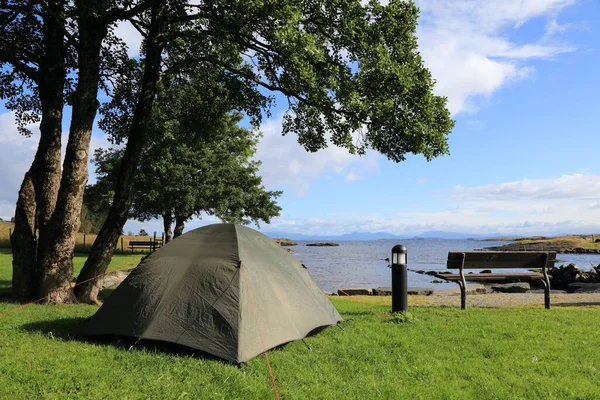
[88,74,281,228]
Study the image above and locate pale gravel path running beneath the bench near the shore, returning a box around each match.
[408,289,600,308]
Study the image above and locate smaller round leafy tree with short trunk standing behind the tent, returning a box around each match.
[91,110,281,247]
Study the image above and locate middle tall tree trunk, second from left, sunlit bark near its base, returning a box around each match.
[39,0,107,303]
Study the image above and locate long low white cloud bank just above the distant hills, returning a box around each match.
[265,174,600,235]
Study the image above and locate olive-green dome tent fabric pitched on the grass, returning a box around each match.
[79,224,342,363]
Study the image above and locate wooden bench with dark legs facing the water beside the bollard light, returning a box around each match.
[443,251,556,310]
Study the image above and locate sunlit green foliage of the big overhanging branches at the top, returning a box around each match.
[100,0,454,162]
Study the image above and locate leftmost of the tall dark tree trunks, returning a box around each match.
[11,0,66,302]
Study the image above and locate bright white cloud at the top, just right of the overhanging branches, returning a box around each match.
[417,0,575,114]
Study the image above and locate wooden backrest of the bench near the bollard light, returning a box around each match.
[446,251,556,269]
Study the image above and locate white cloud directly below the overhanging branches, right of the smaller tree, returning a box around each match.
[256,115,379,196]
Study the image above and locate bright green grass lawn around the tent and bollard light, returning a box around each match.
[0,253,600,399]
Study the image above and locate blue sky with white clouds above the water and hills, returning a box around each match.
[0,0,600,235]
